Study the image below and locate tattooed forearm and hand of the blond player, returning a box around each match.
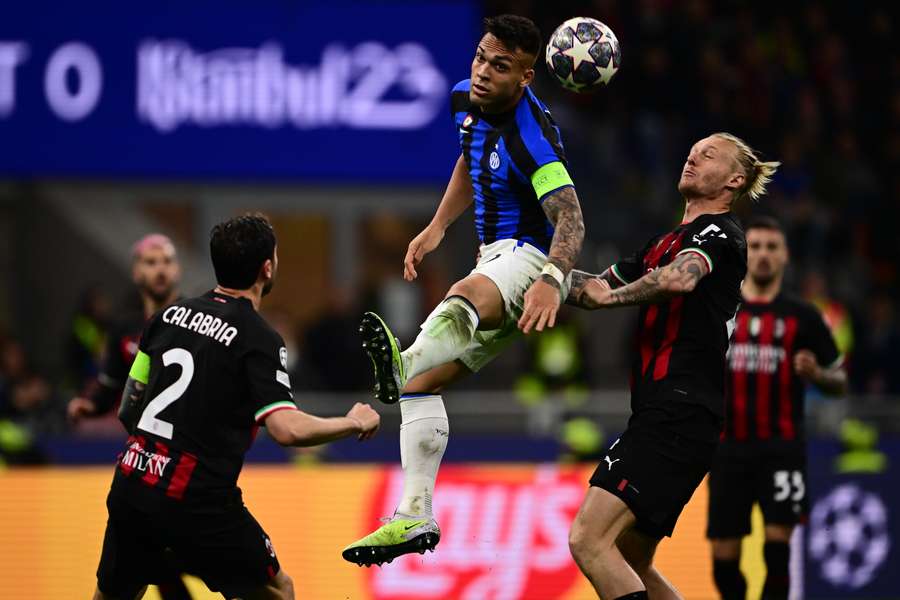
[567,252,709,309]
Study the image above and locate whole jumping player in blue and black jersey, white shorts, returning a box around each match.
[343,15,584,564]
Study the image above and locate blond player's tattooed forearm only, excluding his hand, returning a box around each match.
[610,252,708,306]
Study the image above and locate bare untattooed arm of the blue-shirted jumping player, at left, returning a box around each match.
[403,155,474,281]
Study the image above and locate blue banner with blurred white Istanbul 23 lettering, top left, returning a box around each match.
[0,0,479,181]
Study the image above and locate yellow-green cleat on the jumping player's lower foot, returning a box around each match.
[341,515,441,567]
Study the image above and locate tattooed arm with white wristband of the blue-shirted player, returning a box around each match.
[519,185,584,333]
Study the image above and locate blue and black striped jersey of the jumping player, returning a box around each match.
[450,79,571,253]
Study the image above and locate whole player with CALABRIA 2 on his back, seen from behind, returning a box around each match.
[94,215,380,600]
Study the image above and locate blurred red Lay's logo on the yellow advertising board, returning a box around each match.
[367,465,587,600]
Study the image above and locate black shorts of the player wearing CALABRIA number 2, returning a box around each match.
[97,493,280,598]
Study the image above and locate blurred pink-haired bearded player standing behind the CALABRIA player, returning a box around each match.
[68,233,181,422]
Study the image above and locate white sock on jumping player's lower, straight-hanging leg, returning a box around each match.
[396,394,450,517]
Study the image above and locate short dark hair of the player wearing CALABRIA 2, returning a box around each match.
[209,214,275,290]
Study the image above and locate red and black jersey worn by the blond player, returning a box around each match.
[611,213,747,416]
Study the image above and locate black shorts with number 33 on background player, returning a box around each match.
[706,442,809,539]
